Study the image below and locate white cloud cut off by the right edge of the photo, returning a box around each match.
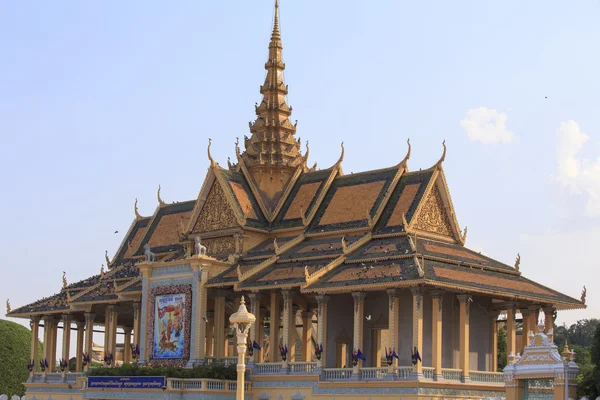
[555,120,600,216]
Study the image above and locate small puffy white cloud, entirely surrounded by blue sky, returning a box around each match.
[460,107,515,144]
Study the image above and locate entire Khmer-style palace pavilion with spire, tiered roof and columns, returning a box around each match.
[7,2,585,400]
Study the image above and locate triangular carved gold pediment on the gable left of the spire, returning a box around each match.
[192,181,239,233]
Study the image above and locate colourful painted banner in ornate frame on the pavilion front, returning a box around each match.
[153,293,187,359]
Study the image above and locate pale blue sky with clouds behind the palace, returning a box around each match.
[0,0,600,346]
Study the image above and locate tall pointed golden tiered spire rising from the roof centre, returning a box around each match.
[241,0,306,197]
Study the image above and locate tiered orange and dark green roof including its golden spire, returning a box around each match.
[8,2,585,317]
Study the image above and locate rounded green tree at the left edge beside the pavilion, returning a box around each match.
[0,319,42,397]
